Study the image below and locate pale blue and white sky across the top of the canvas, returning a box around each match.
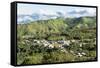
[17,3,96,17]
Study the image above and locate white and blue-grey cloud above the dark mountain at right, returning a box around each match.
[67,7,96,17]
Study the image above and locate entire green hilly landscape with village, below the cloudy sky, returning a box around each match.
[17,17,96,65]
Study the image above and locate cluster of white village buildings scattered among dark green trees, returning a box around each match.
[23,38,96,57]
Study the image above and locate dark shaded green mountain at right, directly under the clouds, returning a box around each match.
[65,16,96,28]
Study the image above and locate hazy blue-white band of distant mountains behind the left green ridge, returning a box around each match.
[17,12,64,24]
